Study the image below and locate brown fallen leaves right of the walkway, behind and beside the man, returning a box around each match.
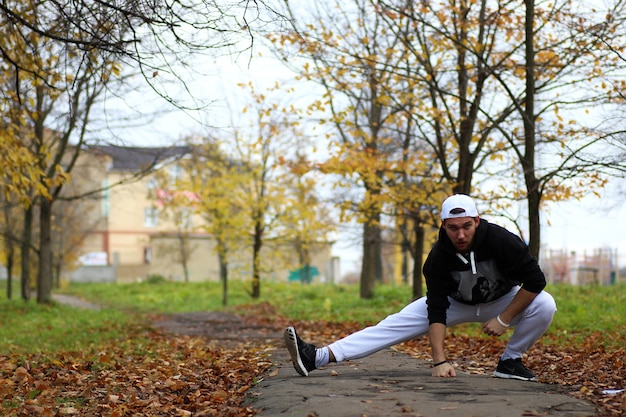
[296,316,626,417]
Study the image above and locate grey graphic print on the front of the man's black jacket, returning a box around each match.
[451,252,517,304]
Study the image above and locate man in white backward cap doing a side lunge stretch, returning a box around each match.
[284,194,556,381]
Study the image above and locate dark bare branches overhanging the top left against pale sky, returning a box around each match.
[0,0,280,103]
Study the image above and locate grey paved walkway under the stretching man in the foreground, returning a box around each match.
[247,348,596,417]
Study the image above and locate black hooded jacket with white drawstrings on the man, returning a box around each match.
[423,219,546,324]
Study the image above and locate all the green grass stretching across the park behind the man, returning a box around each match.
[0,282,626,353]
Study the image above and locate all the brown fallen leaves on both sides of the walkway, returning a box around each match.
[0,305,626,417]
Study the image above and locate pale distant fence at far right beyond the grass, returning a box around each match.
[541,249,620,285]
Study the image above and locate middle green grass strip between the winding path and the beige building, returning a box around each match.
[54,281,411,323]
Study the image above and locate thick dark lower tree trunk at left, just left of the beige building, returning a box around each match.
[37,198,52,303]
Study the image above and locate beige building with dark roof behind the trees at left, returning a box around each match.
[72,146,333,282]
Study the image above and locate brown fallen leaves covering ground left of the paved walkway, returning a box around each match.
[0,333,269,417]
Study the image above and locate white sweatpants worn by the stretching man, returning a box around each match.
[328,287,556,362]
